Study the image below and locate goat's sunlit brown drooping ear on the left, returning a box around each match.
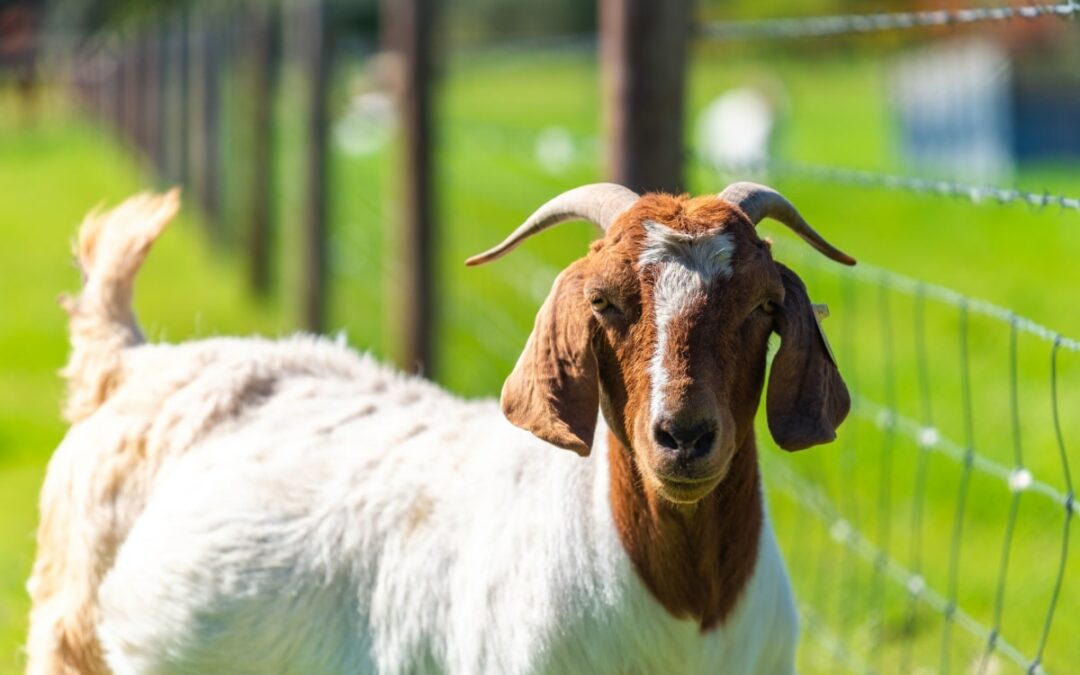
[502,260,599,456]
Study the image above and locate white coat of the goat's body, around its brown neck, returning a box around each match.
[76,337,797,675]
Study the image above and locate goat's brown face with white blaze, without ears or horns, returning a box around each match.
[581,195,785,502]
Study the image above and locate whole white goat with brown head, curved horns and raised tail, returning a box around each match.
[28,183,854,674]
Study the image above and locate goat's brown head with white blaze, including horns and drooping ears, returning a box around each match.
[468,183,854,502]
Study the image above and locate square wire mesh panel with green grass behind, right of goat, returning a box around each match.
[766,248,1080,673]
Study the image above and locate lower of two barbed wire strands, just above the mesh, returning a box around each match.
[696,156,1080,212]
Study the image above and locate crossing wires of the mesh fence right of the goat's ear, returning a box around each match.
[781,233,1080,673]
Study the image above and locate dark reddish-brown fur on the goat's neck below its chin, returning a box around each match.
[608,433,764,632]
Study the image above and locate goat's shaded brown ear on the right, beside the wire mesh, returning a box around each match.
[766,264,851,450]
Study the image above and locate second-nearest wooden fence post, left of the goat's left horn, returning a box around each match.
[380,0,437,376]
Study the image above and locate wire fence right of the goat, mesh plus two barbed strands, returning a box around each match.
[691,1,1080,673]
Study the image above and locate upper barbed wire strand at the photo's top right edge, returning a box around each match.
[698,0,1080,42]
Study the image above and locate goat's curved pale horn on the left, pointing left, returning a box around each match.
[465,183,637,266]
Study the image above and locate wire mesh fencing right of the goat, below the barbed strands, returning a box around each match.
[767,248,1080,673]
